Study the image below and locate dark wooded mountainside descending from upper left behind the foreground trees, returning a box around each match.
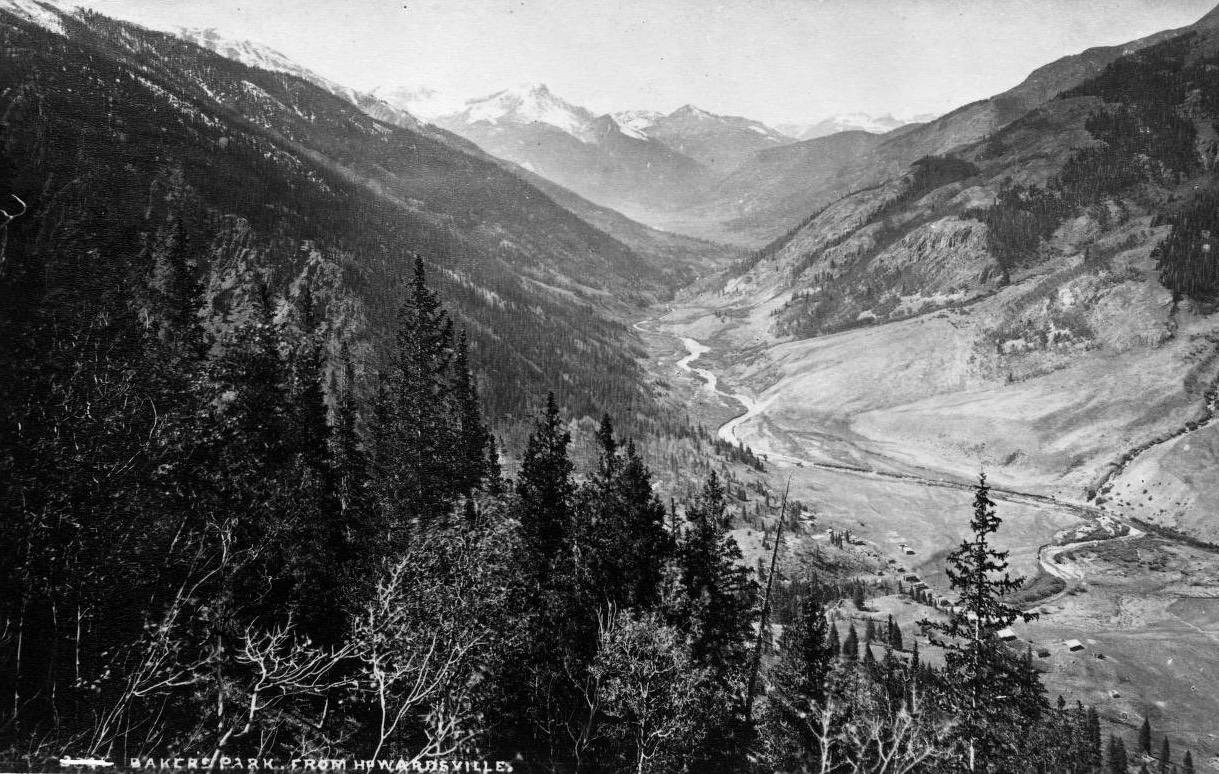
[0,0,687,426]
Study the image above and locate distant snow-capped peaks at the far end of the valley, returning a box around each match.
[373,84,930,230]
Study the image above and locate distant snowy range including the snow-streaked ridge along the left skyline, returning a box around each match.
[114,24,950,246]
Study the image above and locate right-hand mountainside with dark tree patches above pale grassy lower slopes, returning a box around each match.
[687,24,1219,540]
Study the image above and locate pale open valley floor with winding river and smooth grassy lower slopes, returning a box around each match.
[636,281,1219,759]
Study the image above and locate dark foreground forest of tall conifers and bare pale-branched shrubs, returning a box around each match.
[0,236,1192,774]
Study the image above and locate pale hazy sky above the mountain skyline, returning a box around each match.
[78,0,1217,123]
